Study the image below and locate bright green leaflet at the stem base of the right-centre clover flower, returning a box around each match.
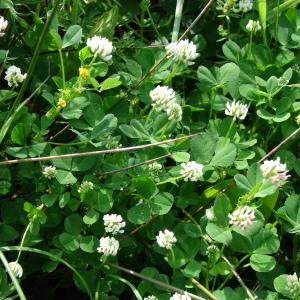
[210,139,237,167]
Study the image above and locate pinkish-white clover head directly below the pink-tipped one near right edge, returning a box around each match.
[228,206,255,230]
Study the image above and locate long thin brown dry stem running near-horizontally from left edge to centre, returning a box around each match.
[0,133,201,166]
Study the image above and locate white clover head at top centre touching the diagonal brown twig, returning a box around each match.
[166,40,199,65]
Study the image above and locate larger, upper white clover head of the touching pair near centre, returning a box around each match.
[149,85,176,111]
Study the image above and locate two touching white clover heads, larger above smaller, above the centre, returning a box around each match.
[149,85,182,121]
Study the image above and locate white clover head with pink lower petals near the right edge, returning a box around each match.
[260,157,290,184]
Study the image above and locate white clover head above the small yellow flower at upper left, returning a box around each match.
[86,35,114,61]
